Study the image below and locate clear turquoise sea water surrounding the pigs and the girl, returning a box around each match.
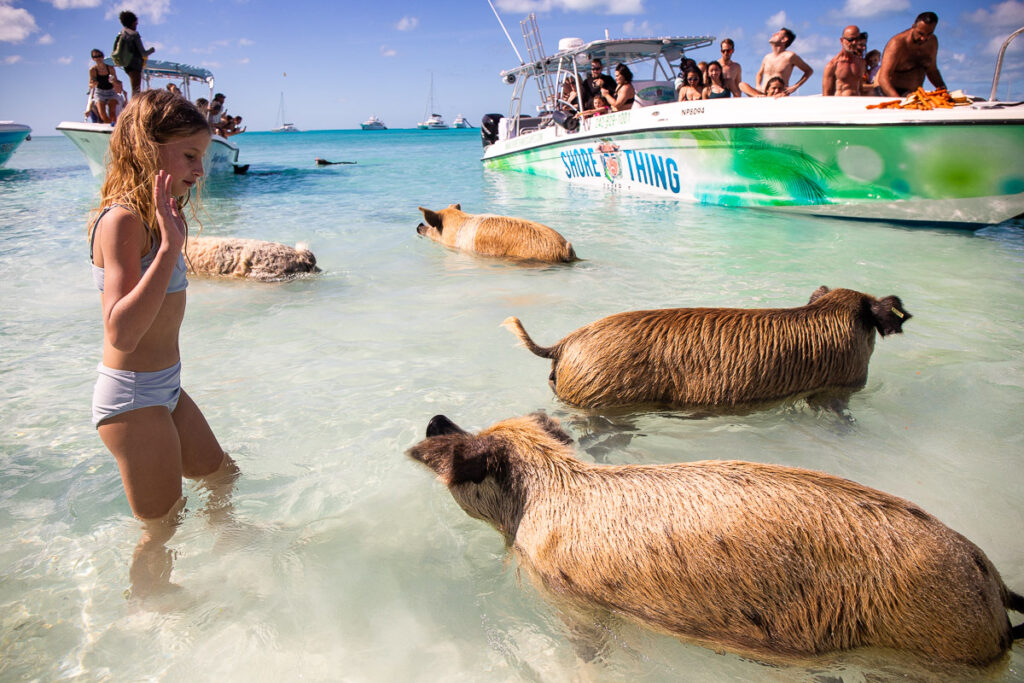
[0,130,1024,681]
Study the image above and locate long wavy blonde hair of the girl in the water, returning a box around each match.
[88,90,212,251]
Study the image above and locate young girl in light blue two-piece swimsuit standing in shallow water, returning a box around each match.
[89,90,237,584]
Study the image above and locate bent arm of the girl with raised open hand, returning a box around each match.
[97,171,190,353]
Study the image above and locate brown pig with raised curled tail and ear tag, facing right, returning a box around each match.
[502,287,910,408]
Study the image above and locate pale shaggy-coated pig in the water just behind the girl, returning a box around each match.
[184,238,319,282]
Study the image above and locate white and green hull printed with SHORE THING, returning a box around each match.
[483,97,1024,227]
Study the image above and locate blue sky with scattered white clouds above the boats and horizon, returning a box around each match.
[0,0,1024,134]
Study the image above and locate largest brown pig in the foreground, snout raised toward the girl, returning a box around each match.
[408,413,1024,666]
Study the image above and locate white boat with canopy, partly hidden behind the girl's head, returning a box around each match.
[57,58,241,176]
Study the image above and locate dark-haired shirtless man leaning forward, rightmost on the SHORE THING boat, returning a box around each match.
[879,12,946,97]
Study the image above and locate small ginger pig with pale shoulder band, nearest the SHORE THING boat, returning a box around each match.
[416,204,577,263]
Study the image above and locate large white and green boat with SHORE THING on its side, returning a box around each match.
[480,19,1024,228]
